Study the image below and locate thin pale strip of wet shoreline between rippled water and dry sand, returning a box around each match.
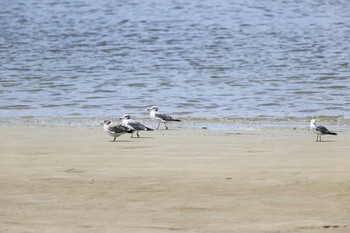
[0,116,350,131]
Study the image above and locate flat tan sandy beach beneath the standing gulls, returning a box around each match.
[0,126,350,233]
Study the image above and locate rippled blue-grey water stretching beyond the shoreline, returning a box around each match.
[0,0,350,122]
